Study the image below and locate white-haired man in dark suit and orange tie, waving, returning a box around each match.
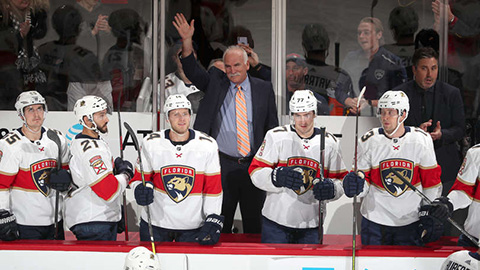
[173,14,278,233]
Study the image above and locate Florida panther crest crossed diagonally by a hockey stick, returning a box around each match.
[380,159,414,197]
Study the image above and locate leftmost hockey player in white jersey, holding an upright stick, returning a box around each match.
[0,91,70,240]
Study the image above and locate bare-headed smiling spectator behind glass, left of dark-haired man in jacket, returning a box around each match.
[342,17,407,115]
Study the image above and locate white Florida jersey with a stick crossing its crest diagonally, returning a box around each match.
[358,127,442,226]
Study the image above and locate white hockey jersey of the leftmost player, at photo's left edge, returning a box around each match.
[0,128,70,226]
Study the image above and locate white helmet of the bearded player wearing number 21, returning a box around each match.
[73,96,108,132]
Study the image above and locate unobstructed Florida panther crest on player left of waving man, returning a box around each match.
[160,165,195,203]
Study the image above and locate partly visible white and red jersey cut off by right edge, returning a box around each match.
[448,144,480,239]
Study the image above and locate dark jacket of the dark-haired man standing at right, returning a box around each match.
[394,80,465,194]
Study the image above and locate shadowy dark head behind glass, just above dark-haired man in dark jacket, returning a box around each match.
[383,6,418,70]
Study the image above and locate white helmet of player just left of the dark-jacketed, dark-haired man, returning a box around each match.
[377,90,410,136]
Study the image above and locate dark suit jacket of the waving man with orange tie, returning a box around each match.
[181,54,278,155]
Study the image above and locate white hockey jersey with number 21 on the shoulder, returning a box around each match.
[65,133,128,228]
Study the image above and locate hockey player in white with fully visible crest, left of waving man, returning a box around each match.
[130,94,224,245]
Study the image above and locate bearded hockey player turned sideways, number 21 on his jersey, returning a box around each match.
[65,96,133,241]
